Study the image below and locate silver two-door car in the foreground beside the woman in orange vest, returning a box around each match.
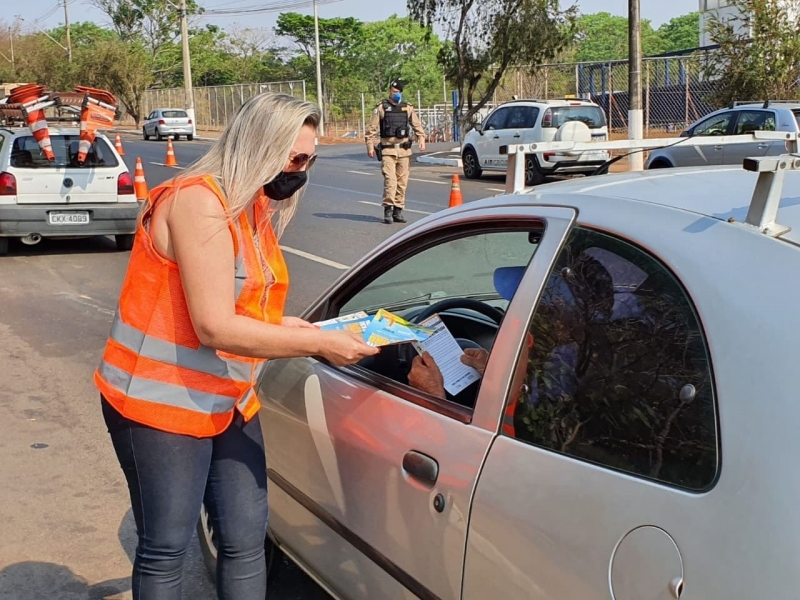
[201,156,800,600]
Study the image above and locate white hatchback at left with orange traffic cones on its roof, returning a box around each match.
[0,127,139,254]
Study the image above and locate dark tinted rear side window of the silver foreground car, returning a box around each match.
[502,229,718,490]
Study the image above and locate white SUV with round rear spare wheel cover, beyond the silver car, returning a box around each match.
[461,100,609,186]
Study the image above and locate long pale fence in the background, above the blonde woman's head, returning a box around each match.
[134,81,306,131]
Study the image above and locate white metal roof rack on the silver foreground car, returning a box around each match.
[500,131,800,237]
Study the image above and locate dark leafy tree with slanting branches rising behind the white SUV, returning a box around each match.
[408,0,577,126]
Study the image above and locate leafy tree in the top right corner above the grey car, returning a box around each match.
[706,0,800,105]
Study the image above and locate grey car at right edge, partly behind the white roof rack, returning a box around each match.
[645,102,800,169]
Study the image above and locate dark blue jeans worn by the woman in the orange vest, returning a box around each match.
[102,399,268,600]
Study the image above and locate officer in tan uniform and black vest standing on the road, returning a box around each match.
[366,79,425,225]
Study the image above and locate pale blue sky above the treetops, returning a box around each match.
[10,0,698,31]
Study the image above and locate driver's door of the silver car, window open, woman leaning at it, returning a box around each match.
[259,206,575,600]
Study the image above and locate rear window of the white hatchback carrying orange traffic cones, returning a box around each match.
[11,133,119,169]
